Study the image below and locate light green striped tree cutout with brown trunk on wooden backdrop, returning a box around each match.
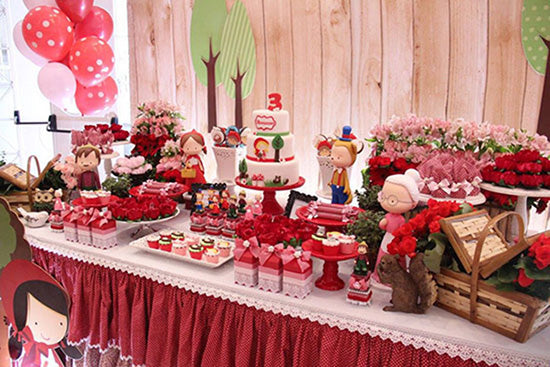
[220,0,256,129]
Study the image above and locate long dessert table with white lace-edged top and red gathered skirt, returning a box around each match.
[26,210,550,367]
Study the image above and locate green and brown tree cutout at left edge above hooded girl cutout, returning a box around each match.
[0,198,31,273]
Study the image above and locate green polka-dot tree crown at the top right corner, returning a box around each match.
[521,0,550,74]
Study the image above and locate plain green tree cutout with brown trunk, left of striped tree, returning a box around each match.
[190,0,227,131]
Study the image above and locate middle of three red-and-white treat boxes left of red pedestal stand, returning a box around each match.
[258,243,284,293]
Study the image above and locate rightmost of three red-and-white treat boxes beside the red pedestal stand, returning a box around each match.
[281,247,313,298]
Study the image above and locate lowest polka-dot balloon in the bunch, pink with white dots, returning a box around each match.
[75,77,118,115]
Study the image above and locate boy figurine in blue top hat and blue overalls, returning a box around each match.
[329,126,364,204]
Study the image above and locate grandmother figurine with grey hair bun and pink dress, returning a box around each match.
[372,169,421,282]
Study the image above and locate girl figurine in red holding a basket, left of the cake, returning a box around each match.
[180,129,206,187]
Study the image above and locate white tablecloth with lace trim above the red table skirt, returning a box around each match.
[27,210,550,367]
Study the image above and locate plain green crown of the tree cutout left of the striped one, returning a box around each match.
[190,0,227,85]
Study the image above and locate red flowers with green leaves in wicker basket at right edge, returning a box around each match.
[487,234,550,301]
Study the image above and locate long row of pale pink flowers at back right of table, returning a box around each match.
[368,115,550,164]
